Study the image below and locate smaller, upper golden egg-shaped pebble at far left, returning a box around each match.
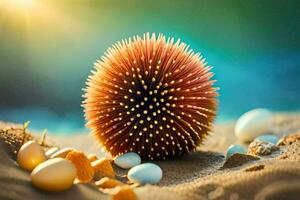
[17,141,47,171]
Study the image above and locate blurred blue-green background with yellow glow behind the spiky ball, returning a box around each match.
[0,0,300,133]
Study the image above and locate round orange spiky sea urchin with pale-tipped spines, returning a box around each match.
[83,34,217,160]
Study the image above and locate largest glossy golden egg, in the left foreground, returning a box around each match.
[31,158,77,192]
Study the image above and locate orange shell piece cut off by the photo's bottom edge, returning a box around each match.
[111,185,138,200]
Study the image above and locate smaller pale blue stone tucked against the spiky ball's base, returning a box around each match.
[114,152,141,169]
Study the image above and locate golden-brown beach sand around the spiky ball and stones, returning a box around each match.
[0,113,300,200]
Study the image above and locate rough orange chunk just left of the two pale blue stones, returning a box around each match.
[91,158,116,178]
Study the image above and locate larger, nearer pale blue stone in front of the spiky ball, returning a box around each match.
[127,163,162,184]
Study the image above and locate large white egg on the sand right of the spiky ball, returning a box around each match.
[234,109,272,142]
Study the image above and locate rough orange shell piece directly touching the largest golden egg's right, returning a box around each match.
[66,150,94,183]
